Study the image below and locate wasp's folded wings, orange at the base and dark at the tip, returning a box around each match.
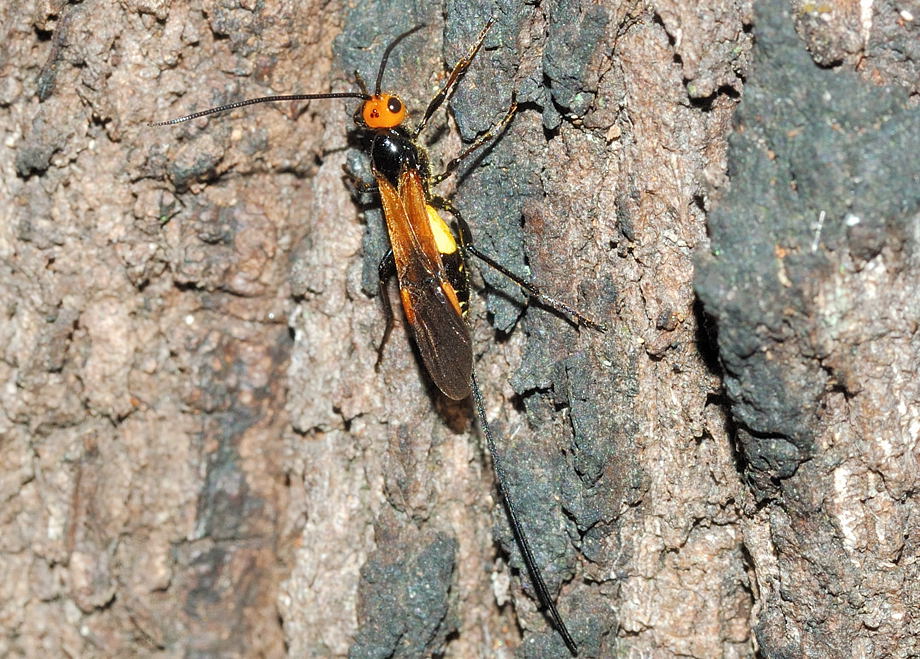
[377,169,473,400]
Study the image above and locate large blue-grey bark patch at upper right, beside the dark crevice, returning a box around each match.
[696,0,920,494]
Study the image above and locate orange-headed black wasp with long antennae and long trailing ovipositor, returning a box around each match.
[148,17,606,655]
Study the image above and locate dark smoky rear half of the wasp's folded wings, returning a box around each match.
[403,281,473,400]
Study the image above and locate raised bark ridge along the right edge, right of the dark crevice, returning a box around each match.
[697,0,920,657]
